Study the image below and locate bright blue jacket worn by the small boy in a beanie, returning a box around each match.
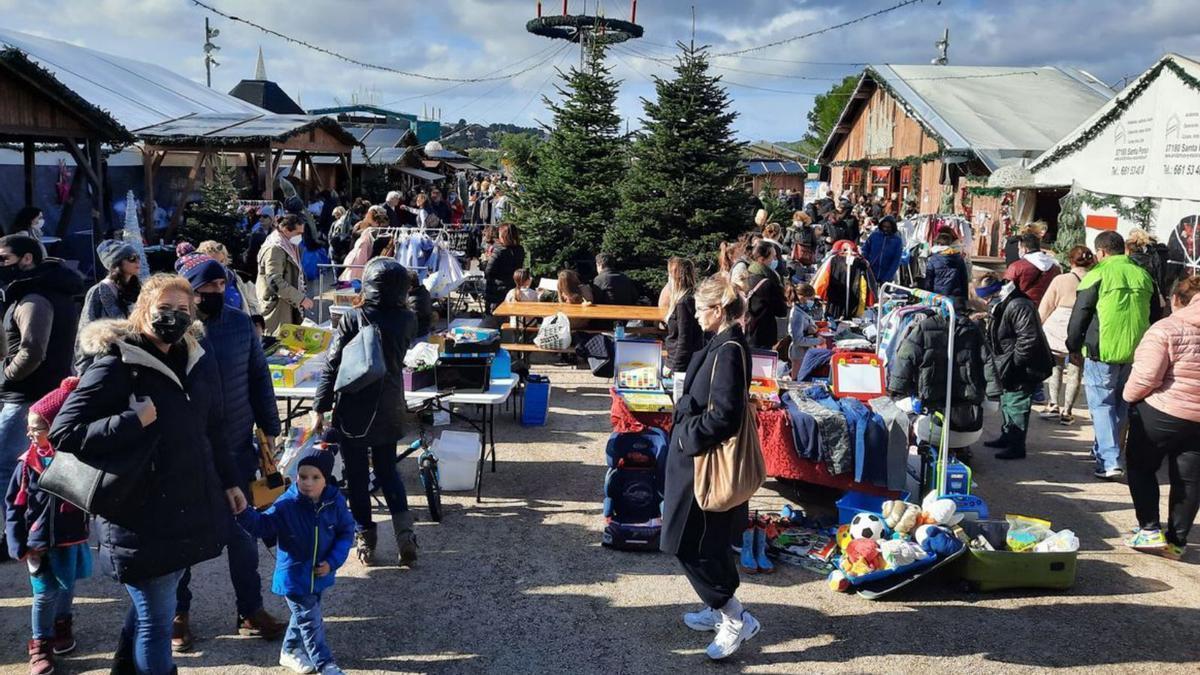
[238,484,354,596]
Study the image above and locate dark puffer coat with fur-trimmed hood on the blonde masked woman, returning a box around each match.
[50,321,238,584]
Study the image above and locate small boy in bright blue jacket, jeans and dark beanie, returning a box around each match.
[238,452,354,675]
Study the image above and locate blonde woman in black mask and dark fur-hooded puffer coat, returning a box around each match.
[50,274,246,674]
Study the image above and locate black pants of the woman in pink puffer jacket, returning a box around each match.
[1126,401,1200,545]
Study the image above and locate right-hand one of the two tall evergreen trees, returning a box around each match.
[604,44,754,285]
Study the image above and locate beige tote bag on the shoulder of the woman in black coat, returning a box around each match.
[694,342,767,512]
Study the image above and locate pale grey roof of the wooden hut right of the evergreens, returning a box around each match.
[821,65,1114,171]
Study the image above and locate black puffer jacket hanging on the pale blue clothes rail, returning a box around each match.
[888,315,988,401]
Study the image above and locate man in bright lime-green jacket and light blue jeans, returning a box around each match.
[1067,232,1162,480]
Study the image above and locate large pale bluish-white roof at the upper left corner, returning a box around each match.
[0,29,266,131]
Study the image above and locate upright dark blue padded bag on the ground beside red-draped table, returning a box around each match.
[601,426,667,551]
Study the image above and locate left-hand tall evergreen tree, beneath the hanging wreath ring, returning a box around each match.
[512,44,628,276]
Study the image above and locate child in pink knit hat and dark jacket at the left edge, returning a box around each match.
[5,377,91,675]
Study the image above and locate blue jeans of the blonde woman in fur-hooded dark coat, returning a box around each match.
[121,571,184,675]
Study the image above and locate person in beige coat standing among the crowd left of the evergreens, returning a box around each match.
[254,215,312,335]
